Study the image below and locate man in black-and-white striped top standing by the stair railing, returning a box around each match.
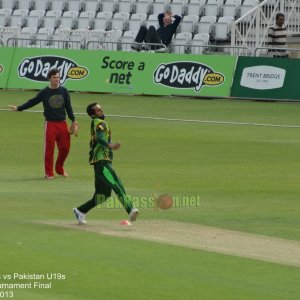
[268,13,288,58]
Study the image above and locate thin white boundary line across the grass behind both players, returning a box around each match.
[0,109,300,128]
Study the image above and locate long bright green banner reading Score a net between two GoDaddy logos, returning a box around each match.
[0,48,237,97]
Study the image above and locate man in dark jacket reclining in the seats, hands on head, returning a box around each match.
[132,11,181,51]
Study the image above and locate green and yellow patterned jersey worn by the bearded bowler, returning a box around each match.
[89,118,112,165]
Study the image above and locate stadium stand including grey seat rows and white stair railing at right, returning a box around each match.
[0,0,300,54]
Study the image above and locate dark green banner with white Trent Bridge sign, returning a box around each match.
[231,57,300,100]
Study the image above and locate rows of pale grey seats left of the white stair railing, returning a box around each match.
[0,0,268,54]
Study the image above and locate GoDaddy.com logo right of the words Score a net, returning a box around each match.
[154,62,224,92]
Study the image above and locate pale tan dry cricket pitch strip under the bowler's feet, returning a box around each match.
[41,220,300,267]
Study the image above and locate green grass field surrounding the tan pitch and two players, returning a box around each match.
[0,91,300,300]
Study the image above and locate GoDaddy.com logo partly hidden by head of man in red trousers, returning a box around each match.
[18,56,88,84]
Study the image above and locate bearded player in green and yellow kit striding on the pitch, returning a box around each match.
[73,102,139,224]
